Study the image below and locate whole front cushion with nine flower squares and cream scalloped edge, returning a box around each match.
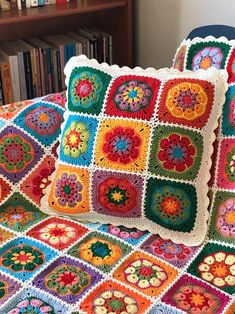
[42,56,227,245]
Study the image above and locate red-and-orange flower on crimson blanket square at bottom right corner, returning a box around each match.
[173,284,220,314]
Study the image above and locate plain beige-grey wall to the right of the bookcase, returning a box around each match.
[134,0,235,68]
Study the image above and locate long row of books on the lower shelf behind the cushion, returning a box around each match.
[0,28,112,105]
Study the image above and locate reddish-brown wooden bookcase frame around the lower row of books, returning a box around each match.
[0,0,133,66]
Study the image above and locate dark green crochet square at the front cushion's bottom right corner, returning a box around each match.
[144,178,197,232]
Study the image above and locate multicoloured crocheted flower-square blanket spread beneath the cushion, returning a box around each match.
[0,93,235,314]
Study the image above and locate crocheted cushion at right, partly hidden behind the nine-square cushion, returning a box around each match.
[174,36,235,243]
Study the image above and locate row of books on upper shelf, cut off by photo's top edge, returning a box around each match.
[9,0,69,10]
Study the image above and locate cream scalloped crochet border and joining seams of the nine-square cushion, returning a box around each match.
[41,55,227,246]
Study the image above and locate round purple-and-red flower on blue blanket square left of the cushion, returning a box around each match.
[25,106,62,136]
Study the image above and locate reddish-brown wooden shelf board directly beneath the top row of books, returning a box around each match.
[0,0,127,26]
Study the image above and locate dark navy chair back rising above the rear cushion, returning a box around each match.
[188,25,235,40]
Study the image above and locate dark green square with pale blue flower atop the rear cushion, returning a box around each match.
[186,41,231,71]
